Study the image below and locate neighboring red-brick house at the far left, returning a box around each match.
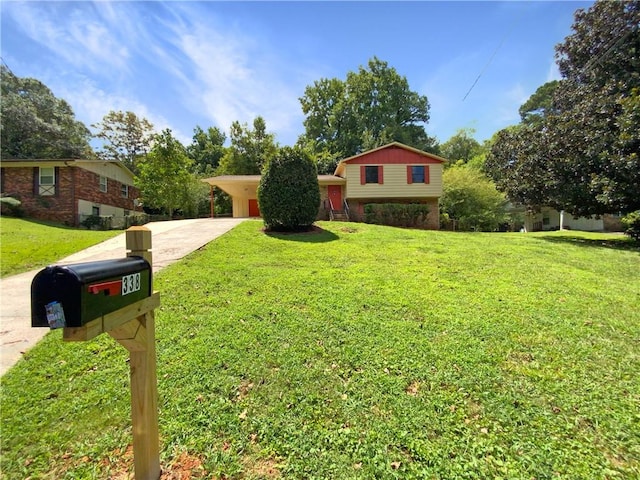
[0,159,140,227]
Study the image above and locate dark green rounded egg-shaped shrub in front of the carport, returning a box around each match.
[258,147,320,231]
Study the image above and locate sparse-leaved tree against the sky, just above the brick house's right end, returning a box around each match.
[91,111,154,173]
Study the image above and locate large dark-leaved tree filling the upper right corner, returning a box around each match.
[486,1,640,215]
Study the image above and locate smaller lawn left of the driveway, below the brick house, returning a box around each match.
[0,217,122,277]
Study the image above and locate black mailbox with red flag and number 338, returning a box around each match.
[31,257,151,328]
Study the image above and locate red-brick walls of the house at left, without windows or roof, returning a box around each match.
[1,164,140,226]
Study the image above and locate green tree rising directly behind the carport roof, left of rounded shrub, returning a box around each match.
[216,117,278,175]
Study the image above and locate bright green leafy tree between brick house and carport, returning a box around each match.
[136,129,201,216]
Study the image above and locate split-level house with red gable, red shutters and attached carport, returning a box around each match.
[204,142,446,230]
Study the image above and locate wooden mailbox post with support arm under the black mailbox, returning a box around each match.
[63,227,161,480]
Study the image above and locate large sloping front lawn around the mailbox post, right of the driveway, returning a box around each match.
[1,221,640,480]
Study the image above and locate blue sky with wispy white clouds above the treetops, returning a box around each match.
[0,0,593,145]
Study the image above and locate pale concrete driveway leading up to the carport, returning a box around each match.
[0,218,245,375]
